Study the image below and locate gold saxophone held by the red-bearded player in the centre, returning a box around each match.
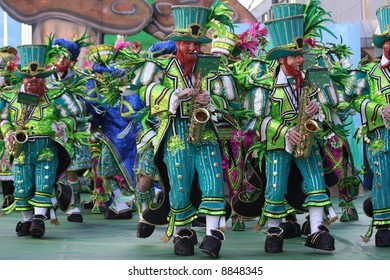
[187,75,210,143]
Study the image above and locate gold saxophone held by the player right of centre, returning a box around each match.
[294,86,319,159]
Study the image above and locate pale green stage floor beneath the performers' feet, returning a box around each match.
[0,192,390,260]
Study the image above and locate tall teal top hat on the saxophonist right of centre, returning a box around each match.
[264,4,306,60]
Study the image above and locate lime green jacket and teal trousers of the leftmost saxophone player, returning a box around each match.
[0,87,78,211]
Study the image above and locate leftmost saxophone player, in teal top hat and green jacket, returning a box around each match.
[0,45,75,238]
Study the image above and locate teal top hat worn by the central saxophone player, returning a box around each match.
[166,6,211,44]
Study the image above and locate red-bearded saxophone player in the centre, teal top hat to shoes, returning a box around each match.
[136,3,232,258]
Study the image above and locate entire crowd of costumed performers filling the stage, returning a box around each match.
[0,0,390,258]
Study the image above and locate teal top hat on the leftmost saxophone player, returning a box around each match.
[15,45,54,78]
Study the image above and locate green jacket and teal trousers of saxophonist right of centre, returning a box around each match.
[252,66,338,224]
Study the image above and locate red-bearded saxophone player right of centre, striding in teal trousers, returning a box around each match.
[253,4,338,253]
